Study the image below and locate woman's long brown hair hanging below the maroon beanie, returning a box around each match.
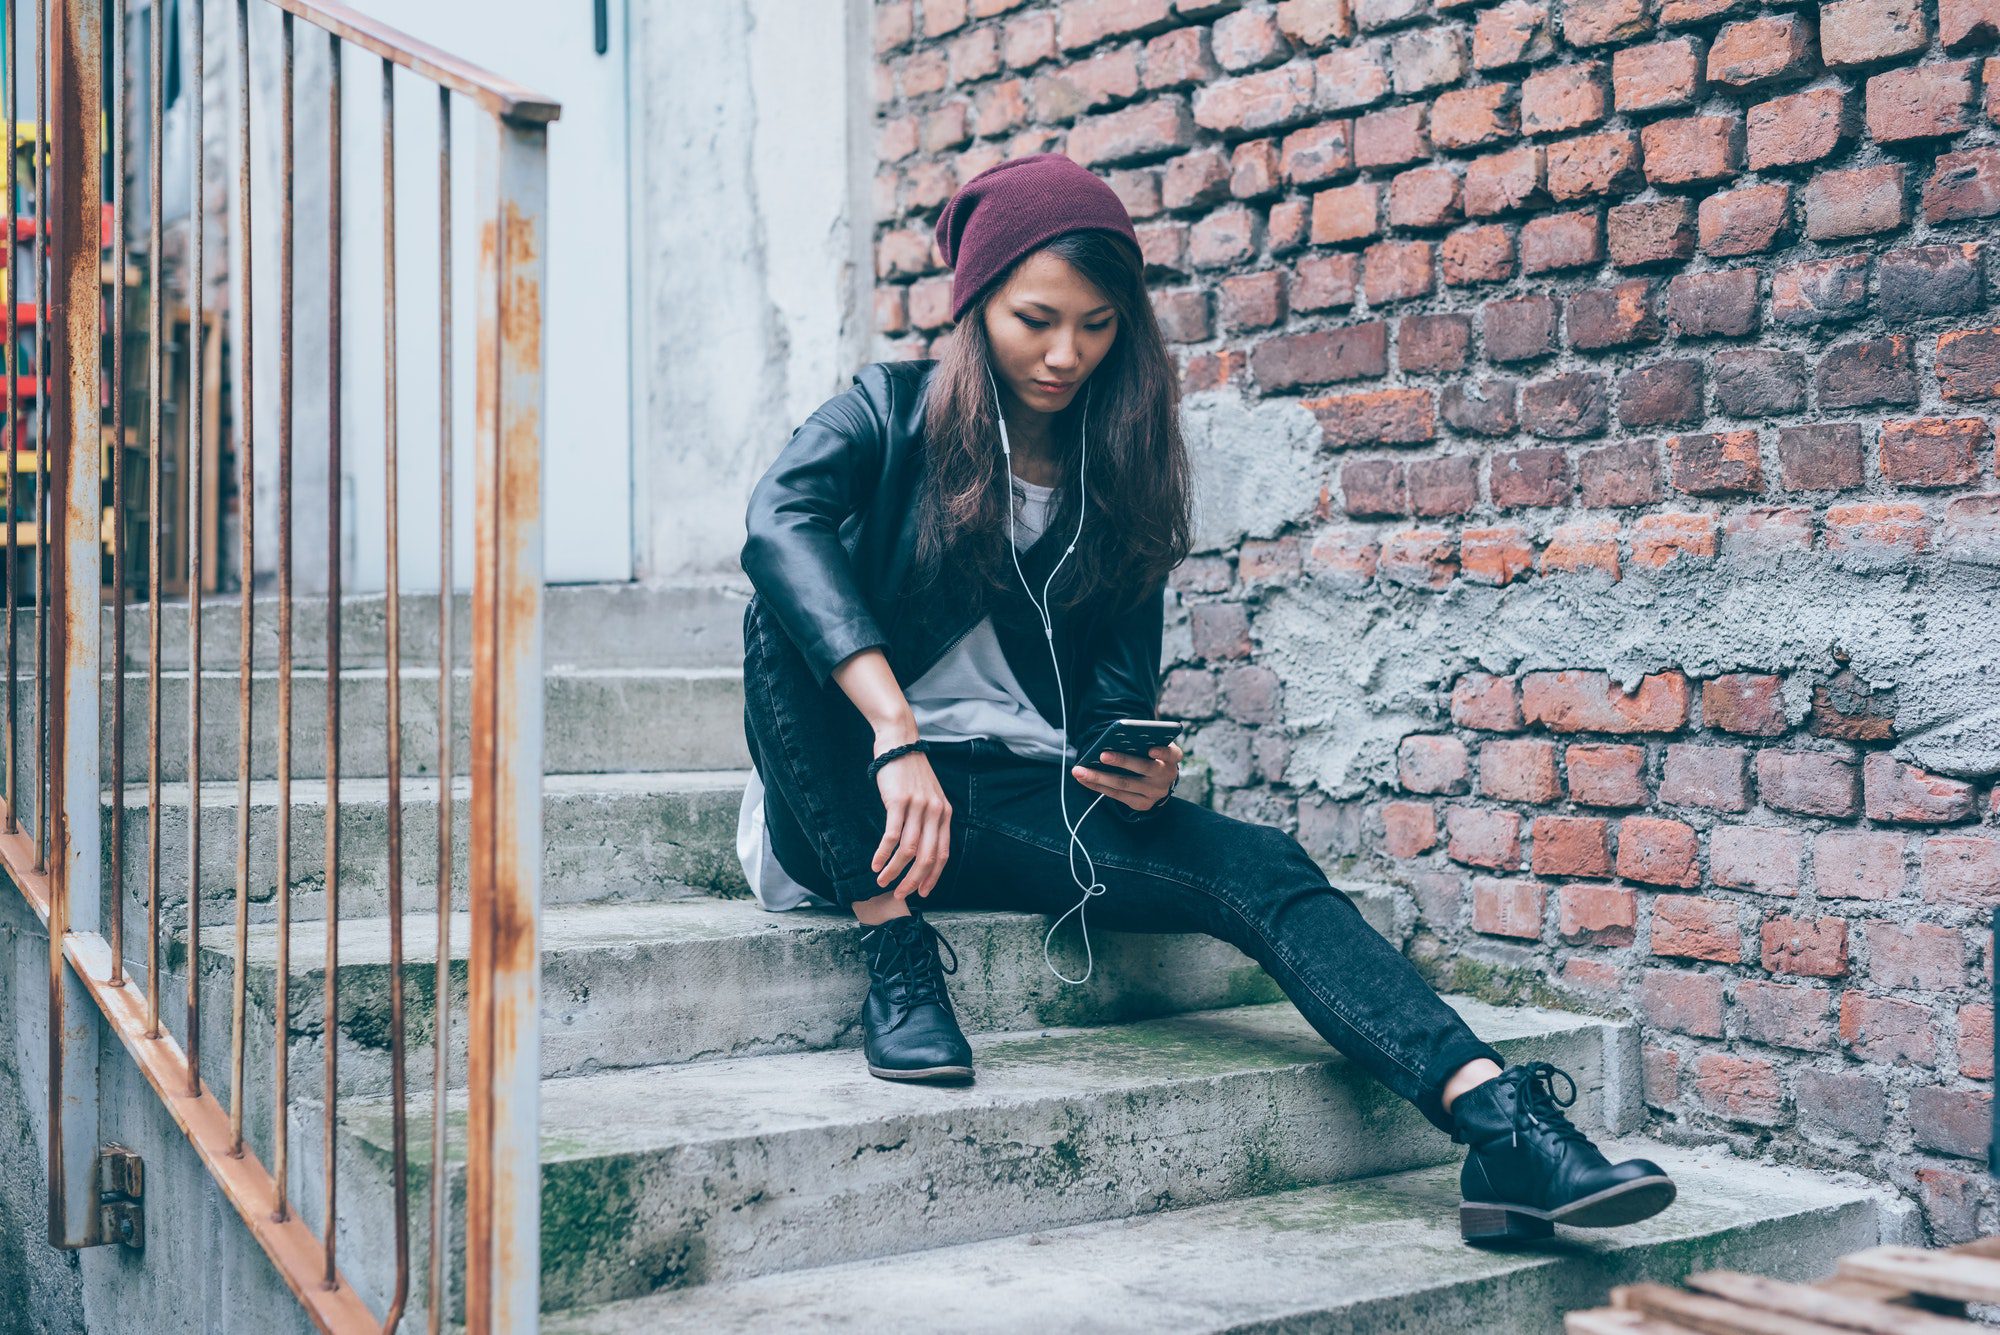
[914,230,1194,612]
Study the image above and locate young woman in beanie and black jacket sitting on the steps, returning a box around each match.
[738,154,1674,1241]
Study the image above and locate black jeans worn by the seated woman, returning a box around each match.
[744,602,1506,1131]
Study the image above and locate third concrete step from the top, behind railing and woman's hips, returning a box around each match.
[104,769,750,921]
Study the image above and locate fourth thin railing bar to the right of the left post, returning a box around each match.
[229,0,256,1157]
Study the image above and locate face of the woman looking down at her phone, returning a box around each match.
[986,250,1118,412]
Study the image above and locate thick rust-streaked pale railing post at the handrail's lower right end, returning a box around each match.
[466,116,548,1335]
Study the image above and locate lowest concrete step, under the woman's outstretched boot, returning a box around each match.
[542,1139,1902,1335]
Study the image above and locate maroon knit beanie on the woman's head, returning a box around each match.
[936,154,1138,322]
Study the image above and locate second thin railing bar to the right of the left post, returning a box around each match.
[146,0,166,1039]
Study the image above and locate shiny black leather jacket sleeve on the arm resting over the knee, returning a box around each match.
[742,364,888,687]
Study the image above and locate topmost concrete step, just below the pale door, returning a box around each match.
[76,578,750,669]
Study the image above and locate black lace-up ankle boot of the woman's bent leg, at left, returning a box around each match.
[862,913,972,1081]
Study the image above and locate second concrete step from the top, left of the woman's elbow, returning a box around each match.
[0,664,750,793]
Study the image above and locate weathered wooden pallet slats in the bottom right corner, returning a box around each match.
[1564,1237,2000,1335]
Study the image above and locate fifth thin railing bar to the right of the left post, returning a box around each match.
[270,10,292,1223]
